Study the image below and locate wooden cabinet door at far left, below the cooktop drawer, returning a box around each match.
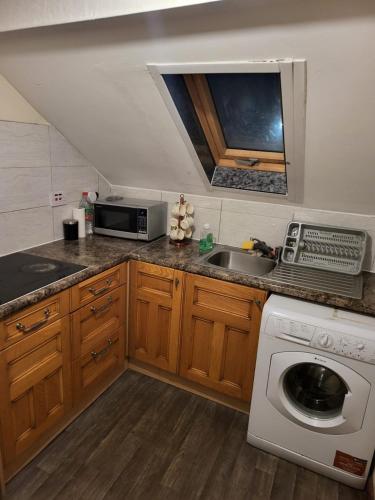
[0,316,71,468]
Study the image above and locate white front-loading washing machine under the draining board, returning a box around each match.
[247,295,375,488]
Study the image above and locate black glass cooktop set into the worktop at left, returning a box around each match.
[0,252,85,304]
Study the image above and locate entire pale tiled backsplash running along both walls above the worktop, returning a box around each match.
[0,121,375,272]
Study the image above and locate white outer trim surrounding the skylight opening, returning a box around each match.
[147,58,306,203]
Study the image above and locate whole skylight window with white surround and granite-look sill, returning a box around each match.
[151,61,305,199]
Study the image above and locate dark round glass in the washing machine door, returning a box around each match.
[284,363,348,418]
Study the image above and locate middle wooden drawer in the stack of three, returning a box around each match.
[72,286,126,359]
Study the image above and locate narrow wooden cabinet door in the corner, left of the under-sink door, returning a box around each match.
[129,262,184,373]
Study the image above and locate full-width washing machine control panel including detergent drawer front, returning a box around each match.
[265,315,375,364]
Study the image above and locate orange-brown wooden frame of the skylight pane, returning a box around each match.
[183,73,286,174]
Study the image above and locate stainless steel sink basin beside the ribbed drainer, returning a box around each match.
[203,250,276,276]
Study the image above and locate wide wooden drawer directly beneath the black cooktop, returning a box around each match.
[0,290,69,349]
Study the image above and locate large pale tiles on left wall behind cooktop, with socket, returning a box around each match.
[0,121,109,255]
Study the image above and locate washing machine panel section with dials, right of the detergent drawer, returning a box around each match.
[310,328,375,364]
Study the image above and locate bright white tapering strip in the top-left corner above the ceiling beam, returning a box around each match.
[0,0,220,31]
